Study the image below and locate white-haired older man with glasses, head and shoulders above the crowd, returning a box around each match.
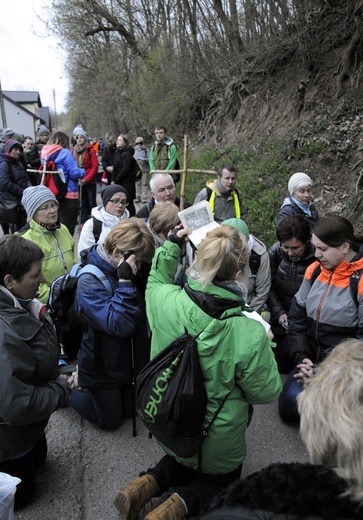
[136,173,190,220]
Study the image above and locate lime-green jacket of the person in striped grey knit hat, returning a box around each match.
[16,219,75,304]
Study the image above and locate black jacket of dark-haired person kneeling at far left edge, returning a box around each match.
[0,290,71,462]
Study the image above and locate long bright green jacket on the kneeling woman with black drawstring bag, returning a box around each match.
[146,241,281,474]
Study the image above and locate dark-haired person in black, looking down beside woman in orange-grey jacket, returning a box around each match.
[267,217,315,373]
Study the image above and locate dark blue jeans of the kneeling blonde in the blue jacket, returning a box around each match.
[69,388,124,430]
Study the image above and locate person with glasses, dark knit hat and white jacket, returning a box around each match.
[78,184,130,256]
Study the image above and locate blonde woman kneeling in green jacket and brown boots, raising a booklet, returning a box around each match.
[115,226,281,520]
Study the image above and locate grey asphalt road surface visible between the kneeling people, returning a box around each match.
[15,394,308,520]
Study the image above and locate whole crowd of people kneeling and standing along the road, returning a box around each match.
[0,125,363,520]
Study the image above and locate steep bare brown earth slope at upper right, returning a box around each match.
[200,0,363,230]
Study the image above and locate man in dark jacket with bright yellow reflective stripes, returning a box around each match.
[194,164,248,224]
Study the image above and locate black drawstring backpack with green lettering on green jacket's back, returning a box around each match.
[136,333,229,464]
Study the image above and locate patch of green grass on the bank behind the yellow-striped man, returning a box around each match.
[178,140,326,248]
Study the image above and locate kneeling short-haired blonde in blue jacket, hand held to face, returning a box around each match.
[70,218,155,430]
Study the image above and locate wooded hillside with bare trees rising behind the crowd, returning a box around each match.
[49,0,363,246]
